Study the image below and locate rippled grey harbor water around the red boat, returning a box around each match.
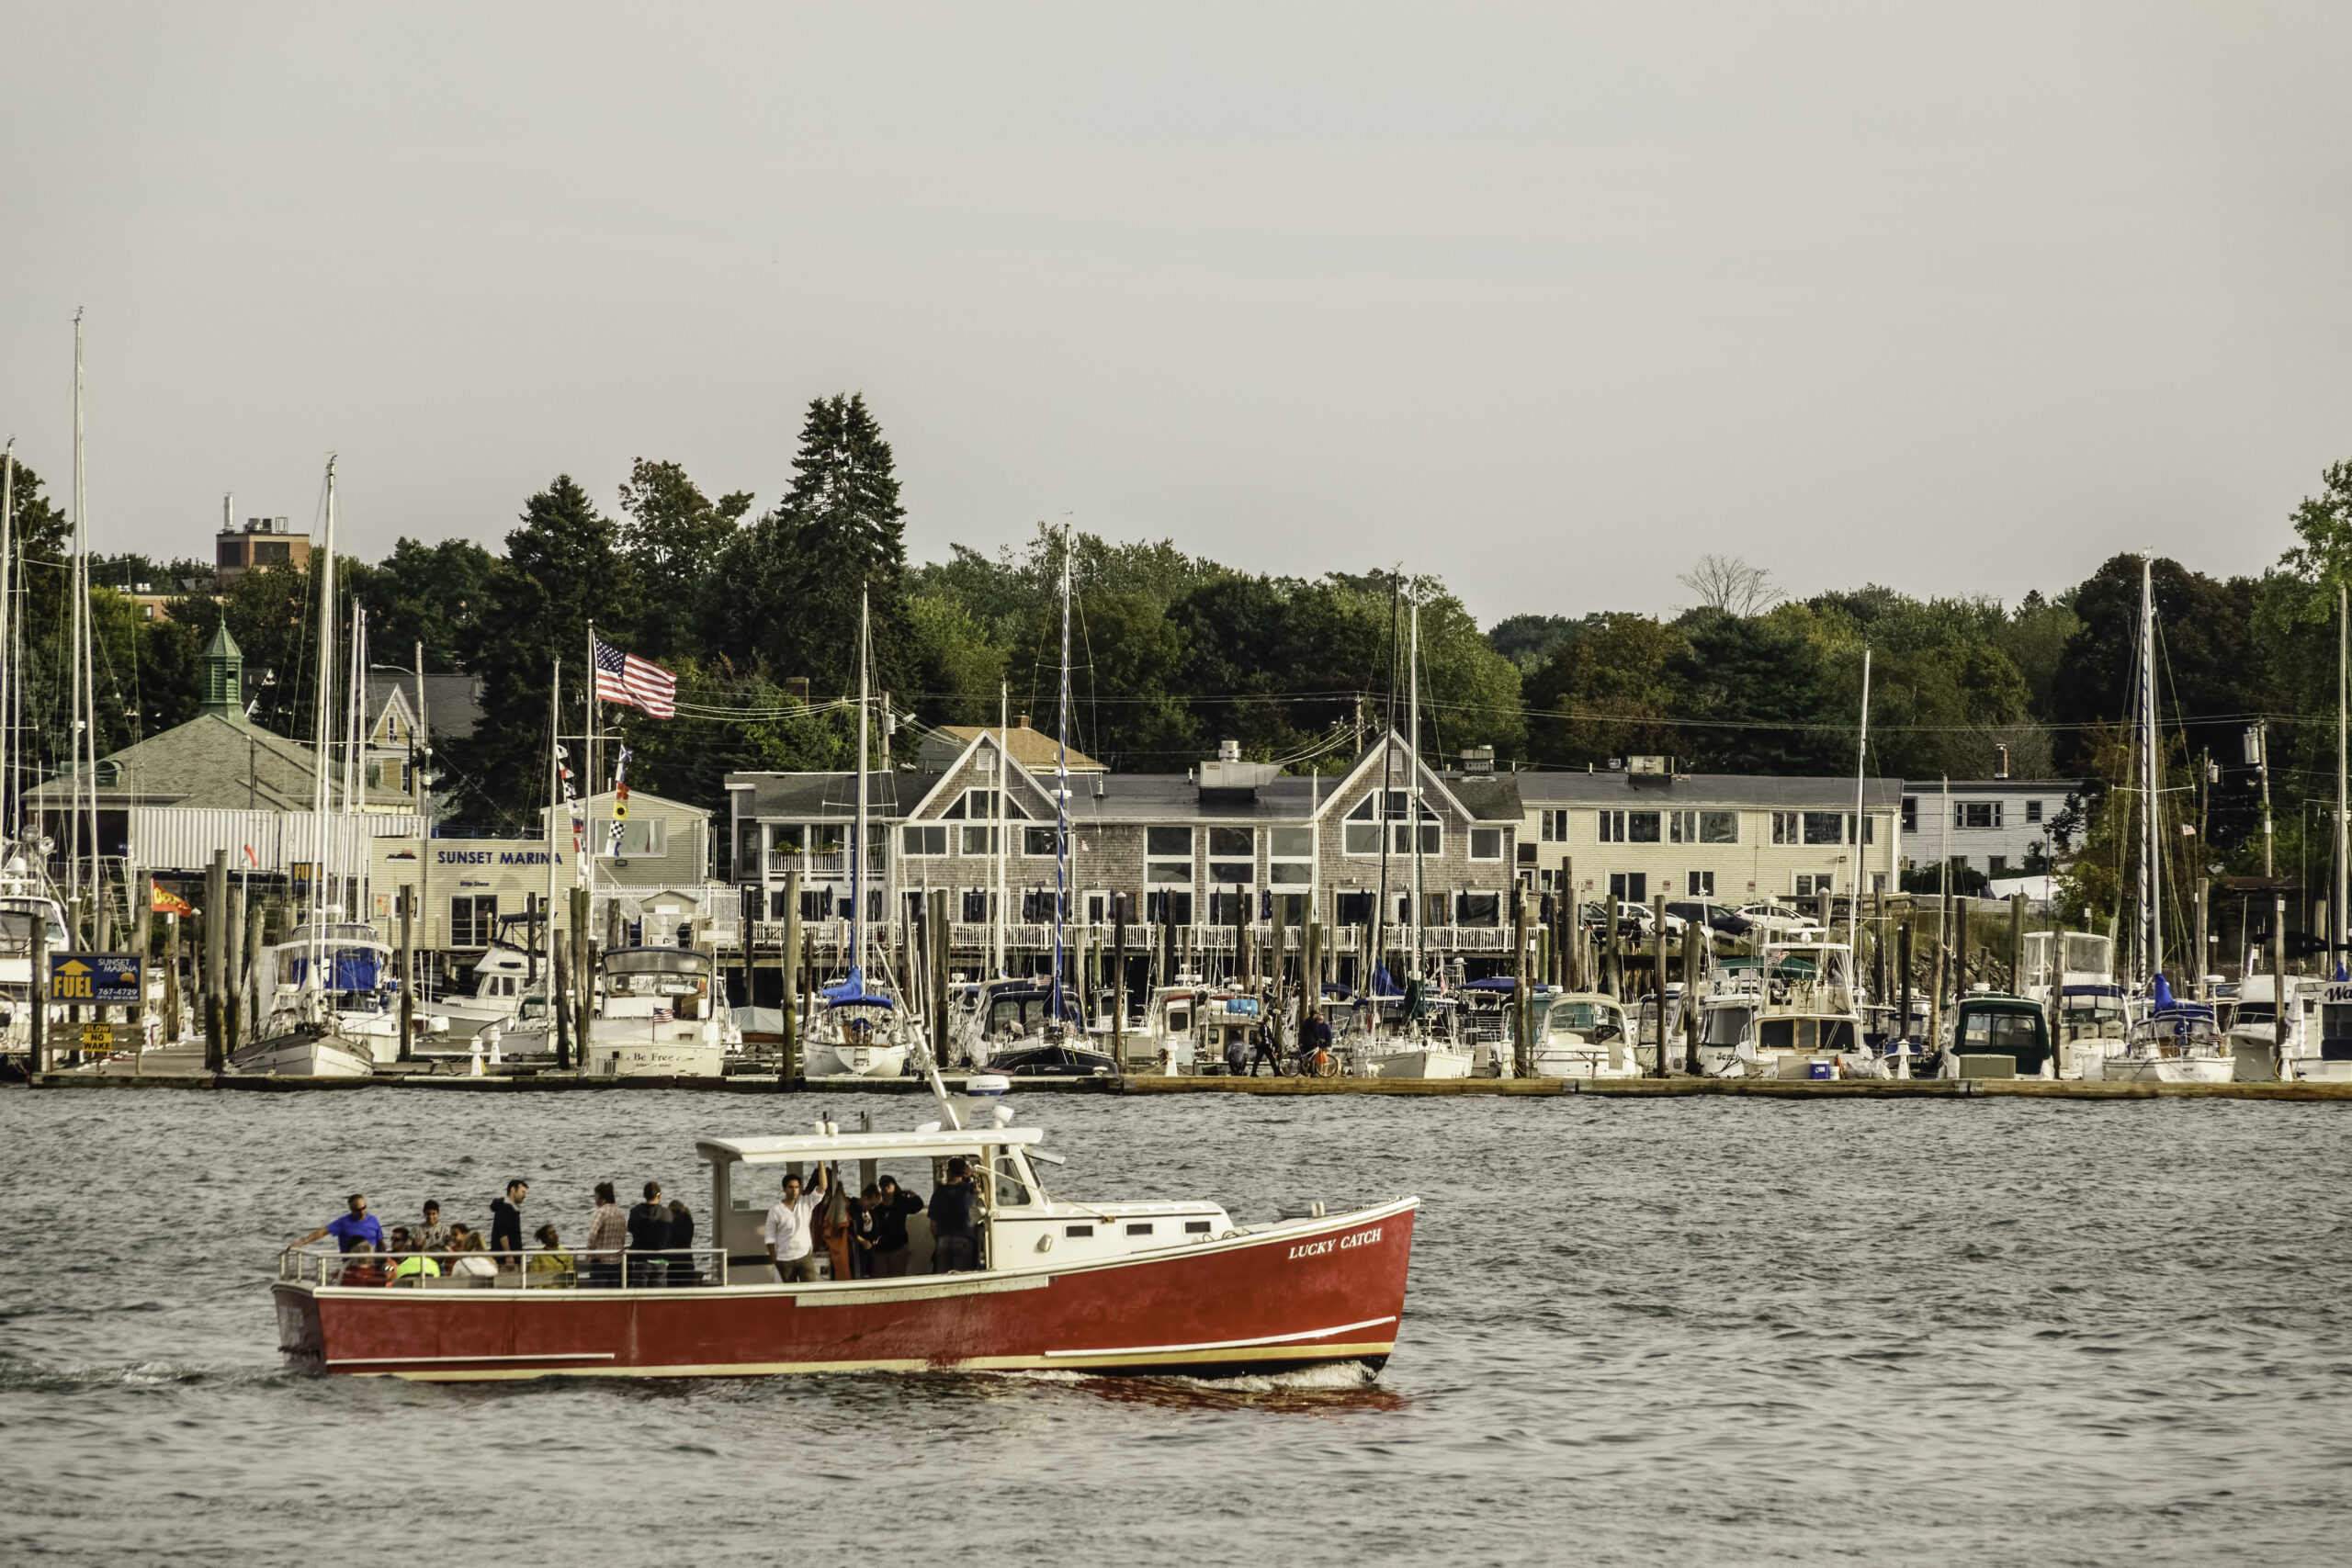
[0,1090,2352,1565]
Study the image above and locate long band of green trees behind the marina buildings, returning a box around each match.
[17,395,2352,926]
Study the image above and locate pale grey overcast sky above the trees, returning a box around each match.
[0,0,2352,621]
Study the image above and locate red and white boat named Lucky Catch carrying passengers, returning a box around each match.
[273,1058,1420,1382]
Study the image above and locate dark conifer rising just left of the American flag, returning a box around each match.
[447,475,638,823]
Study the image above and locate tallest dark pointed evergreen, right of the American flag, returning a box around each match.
[713,395,912,694]
